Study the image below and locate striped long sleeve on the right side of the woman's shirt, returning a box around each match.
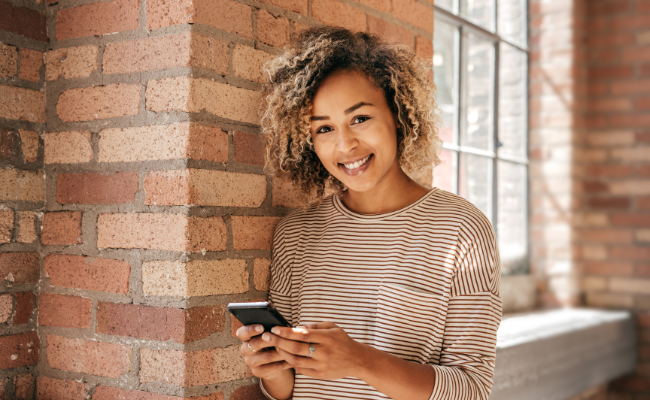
[430,209,502,400]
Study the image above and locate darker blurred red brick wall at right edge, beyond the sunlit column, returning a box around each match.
[576,0,650,400]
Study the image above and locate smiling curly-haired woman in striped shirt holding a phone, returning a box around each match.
[237,28,501,400]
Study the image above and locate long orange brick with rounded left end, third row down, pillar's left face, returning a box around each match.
[56,84,142,122]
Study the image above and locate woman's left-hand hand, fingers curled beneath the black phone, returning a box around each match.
[236,325,292,380]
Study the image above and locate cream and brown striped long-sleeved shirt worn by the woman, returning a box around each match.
[261,188,501,400]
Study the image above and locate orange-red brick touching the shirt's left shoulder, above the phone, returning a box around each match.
[230,215,280,250]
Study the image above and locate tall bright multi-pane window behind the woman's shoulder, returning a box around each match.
[433,0,528,274]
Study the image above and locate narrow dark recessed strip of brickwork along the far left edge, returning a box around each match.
[0,1,48,399]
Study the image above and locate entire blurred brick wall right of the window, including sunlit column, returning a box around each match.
[530,0,650,400]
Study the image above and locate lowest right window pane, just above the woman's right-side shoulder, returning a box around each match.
[497,161,528,273]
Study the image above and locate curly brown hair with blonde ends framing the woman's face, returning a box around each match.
[261,27,441,202]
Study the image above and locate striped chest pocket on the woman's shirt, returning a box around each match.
[373,283,447,364]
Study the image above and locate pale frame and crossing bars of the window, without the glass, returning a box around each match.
[434,0,531,275]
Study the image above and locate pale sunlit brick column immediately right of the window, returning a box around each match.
[529,0,584,307]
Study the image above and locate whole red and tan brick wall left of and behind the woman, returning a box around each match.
[0,0,433,400]
